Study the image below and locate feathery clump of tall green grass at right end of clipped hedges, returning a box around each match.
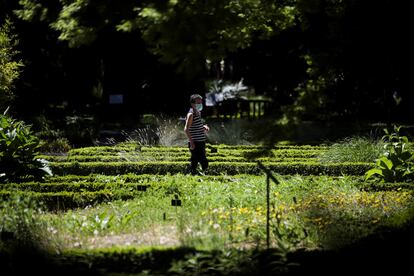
[319,136,384,163]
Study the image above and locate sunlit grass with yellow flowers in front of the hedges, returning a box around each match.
[25,175,413,253]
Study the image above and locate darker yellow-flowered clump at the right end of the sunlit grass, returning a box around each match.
[295,181,413,248]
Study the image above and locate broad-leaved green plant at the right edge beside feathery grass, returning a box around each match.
[365,125,414,182]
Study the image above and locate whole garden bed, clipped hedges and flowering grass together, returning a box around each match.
[0,145,414,275]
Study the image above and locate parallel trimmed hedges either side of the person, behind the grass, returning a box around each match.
[41,144,374,175]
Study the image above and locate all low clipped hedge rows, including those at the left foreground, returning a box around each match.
[0,144,372,210]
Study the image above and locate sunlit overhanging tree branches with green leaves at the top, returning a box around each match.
[17,0,294,78]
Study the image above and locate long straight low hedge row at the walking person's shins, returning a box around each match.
[50,161,373,175]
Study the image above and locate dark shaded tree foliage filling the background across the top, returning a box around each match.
[0,0,414,128]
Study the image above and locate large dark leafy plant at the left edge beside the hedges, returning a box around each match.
[0,114,52,182]
